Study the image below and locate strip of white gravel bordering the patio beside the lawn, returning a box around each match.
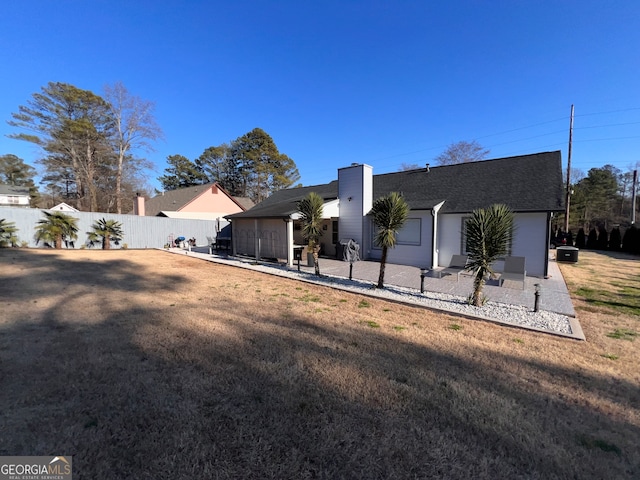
[198,251,574,335]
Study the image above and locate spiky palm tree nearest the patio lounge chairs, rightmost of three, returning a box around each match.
[466,204,513,307]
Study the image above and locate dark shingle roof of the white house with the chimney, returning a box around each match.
[228,151,564,219]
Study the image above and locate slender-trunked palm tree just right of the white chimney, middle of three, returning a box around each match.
[371,192,409,288]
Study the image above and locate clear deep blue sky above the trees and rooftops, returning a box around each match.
[0,0,640,191]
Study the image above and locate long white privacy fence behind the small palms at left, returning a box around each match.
[0,207,229,248]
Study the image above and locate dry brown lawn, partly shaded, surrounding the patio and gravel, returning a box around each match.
[0,249,640,479]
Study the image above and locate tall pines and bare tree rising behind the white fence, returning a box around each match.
[8,82,162,213]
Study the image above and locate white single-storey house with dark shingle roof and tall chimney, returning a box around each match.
[227,151,564,276]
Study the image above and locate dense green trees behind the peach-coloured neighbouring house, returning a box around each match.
[158,128,300,203]
